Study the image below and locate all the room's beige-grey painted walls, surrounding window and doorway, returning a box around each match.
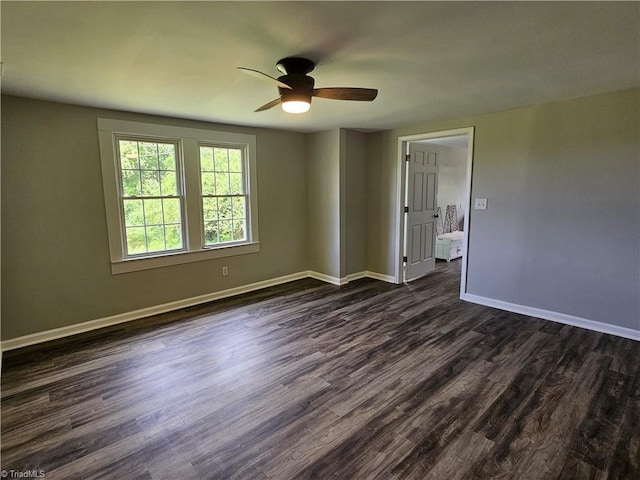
[1,90,640,339]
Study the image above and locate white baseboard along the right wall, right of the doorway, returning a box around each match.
[460,293,640,341]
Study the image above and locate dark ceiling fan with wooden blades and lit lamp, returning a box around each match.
[238,57,378,113]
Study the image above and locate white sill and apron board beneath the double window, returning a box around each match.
[111,242,260,275]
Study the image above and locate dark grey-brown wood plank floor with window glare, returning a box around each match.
[1,261,640,480]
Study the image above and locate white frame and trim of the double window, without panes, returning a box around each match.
[98,118,260,274]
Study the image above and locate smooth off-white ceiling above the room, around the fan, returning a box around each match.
[0,0,640,131]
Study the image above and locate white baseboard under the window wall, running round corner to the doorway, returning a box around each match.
[0,271,393,350]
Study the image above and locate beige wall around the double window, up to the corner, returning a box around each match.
[2,97,308,339]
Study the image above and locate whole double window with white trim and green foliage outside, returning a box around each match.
[98,119,259,273]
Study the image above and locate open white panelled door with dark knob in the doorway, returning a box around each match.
[404,143,438,282]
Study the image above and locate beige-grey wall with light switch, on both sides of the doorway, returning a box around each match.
[367,89,640,330]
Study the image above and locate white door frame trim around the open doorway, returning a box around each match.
[394,127,475,296]
